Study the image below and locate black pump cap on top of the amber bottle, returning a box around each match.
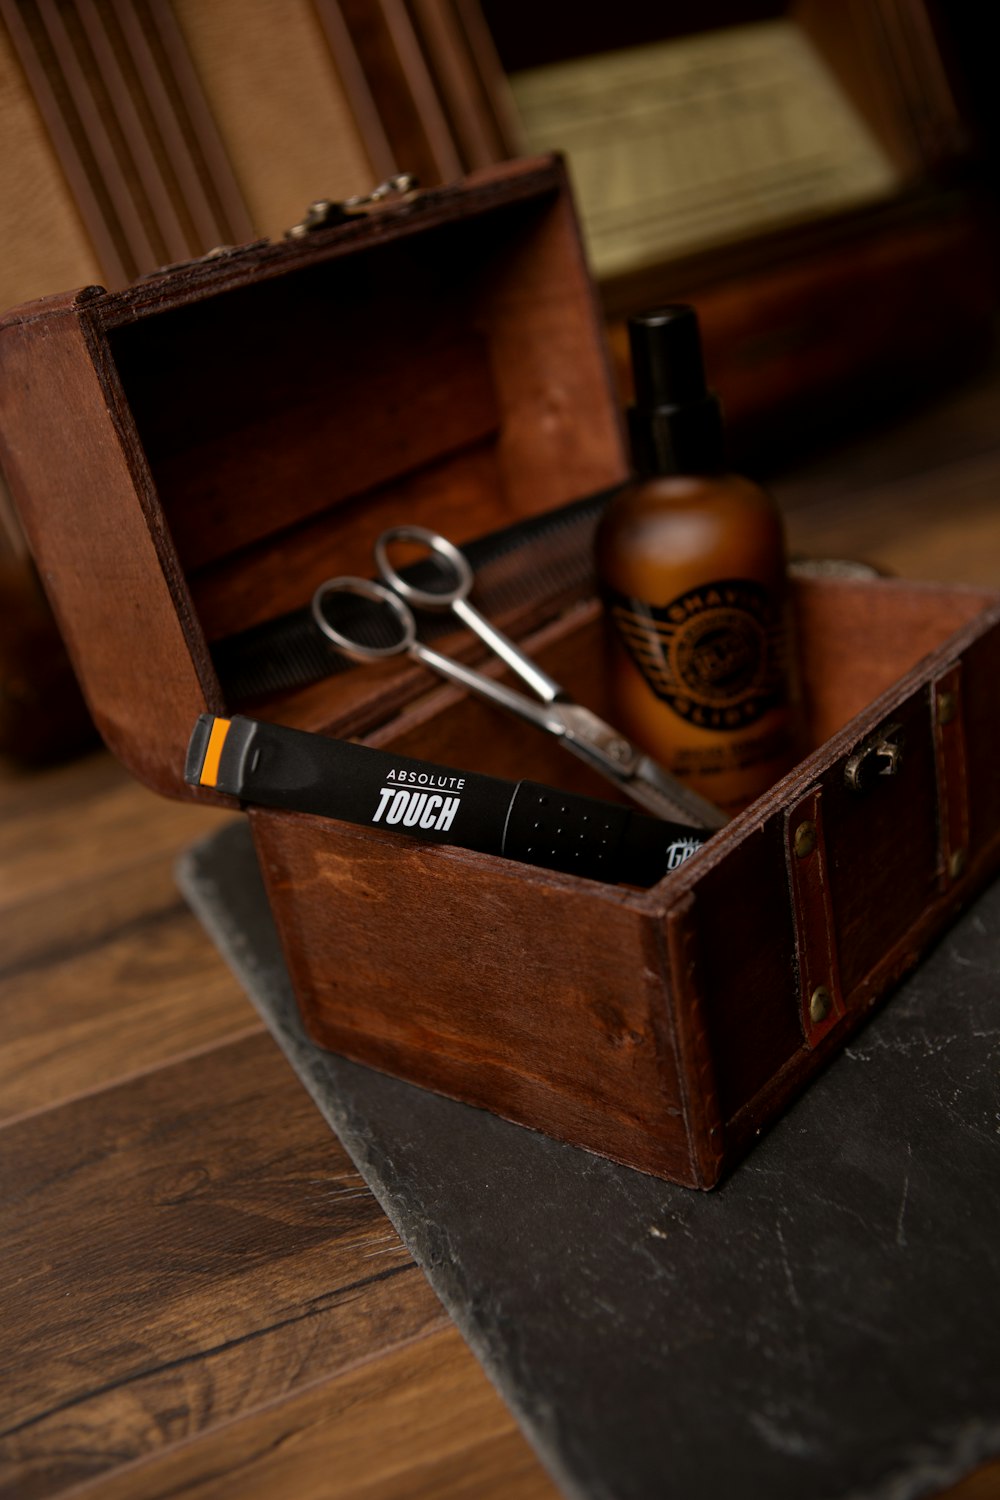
[628,303,726,476]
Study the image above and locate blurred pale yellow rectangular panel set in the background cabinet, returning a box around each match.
[510,17,903,279]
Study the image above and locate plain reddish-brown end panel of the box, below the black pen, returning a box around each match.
[252,809,693,1182]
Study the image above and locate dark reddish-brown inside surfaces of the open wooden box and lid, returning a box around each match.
[95,188,982,816]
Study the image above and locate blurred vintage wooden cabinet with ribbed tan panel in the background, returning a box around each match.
[0,0,997,426]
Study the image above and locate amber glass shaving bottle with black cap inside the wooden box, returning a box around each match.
[597,306,802,813]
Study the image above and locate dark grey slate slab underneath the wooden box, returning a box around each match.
[178,825,1000,1500]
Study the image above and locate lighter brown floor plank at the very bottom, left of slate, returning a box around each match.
[60,1329,559,1500]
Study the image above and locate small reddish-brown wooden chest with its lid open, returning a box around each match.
[0,159,1000,1187]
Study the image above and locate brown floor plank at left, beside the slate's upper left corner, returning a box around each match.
[0,755,259,1121]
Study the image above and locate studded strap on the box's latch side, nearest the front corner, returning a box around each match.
[786,786,844,1047]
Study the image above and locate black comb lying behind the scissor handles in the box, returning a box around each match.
[211,491,613,705]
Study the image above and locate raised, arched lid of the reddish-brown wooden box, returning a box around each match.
[0,158,627,795]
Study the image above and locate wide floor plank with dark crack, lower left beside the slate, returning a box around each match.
[0,1037,447,1500]
